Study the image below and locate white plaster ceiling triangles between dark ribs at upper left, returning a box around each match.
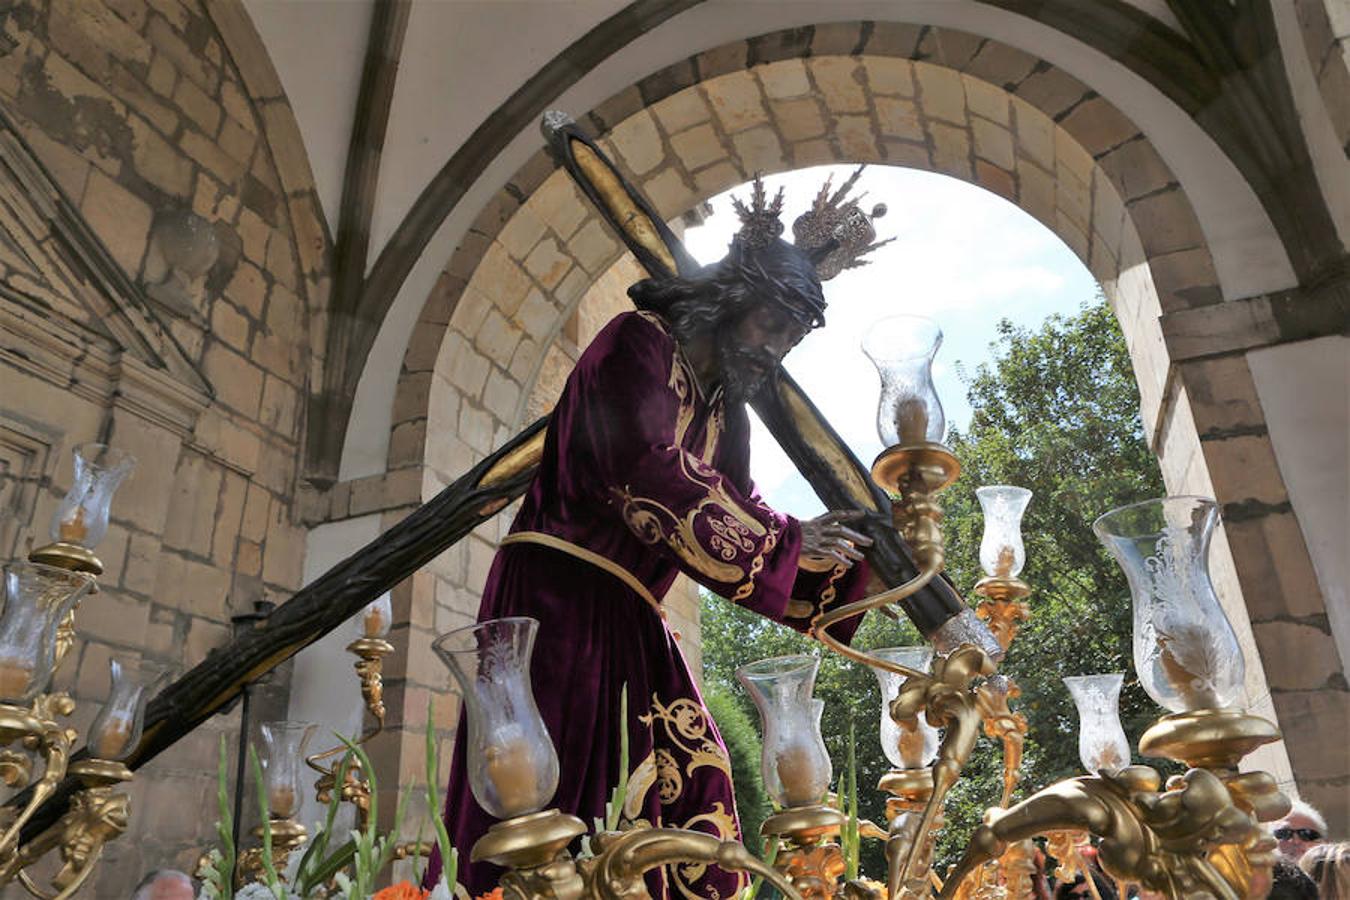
[244,0,1180,271]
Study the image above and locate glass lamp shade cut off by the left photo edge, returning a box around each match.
[0,563,93,704]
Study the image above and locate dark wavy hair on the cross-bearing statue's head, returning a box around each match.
[628,239,825,341]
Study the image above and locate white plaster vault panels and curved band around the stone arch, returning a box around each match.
[237,0,1295,478]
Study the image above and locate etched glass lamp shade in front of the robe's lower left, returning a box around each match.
[432,617,558,819]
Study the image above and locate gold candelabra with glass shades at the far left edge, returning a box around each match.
[0,444,159,900]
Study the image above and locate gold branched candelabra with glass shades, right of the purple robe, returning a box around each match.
[469,315,1288,900]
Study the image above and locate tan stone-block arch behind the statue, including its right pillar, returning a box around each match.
[386,24,1339,825]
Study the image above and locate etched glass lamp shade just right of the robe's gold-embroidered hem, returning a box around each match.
[736,656,833,807]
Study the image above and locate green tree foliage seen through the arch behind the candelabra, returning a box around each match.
[703,302,1164,877]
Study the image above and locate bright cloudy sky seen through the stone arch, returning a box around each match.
[684,166,1096,518]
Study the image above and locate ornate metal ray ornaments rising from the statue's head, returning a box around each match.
[732,166,895,281]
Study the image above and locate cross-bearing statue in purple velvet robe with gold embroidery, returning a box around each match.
[428,172,875,897]
